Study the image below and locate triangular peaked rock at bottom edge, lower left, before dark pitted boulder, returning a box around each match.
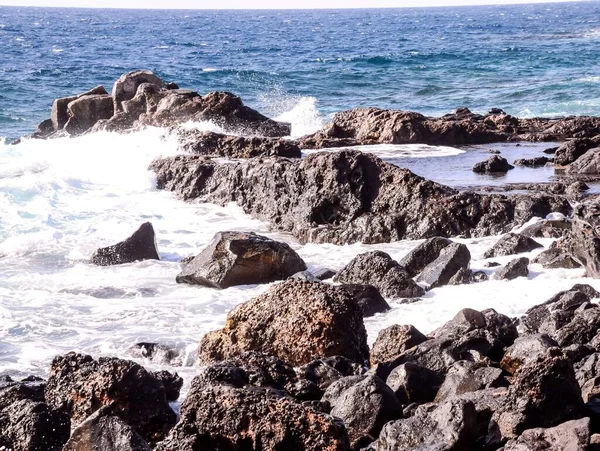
[63,406,152,451]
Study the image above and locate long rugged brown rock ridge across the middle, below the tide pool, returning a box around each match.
[152,151,571,244]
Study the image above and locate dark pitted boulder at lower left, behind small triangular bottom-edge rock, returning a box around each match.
[45,352,176,443]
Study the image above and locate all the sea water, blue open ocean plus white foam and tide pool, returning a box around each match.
[0,2,600,392]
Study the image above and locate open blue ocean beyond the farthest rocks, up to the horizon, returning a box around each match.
[0,1,600,138]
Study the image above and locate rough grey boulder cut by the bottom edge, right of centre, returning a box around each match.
[367,400,478,451]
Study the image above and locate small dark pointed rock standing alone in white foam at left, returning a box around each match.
[91,222,160,266]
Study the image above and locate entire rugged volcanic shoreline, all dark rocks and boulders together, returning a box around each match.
[5,71,600,451]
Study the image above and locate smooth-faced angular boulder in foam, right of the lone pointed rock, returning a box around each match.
[176,232,306,289]
